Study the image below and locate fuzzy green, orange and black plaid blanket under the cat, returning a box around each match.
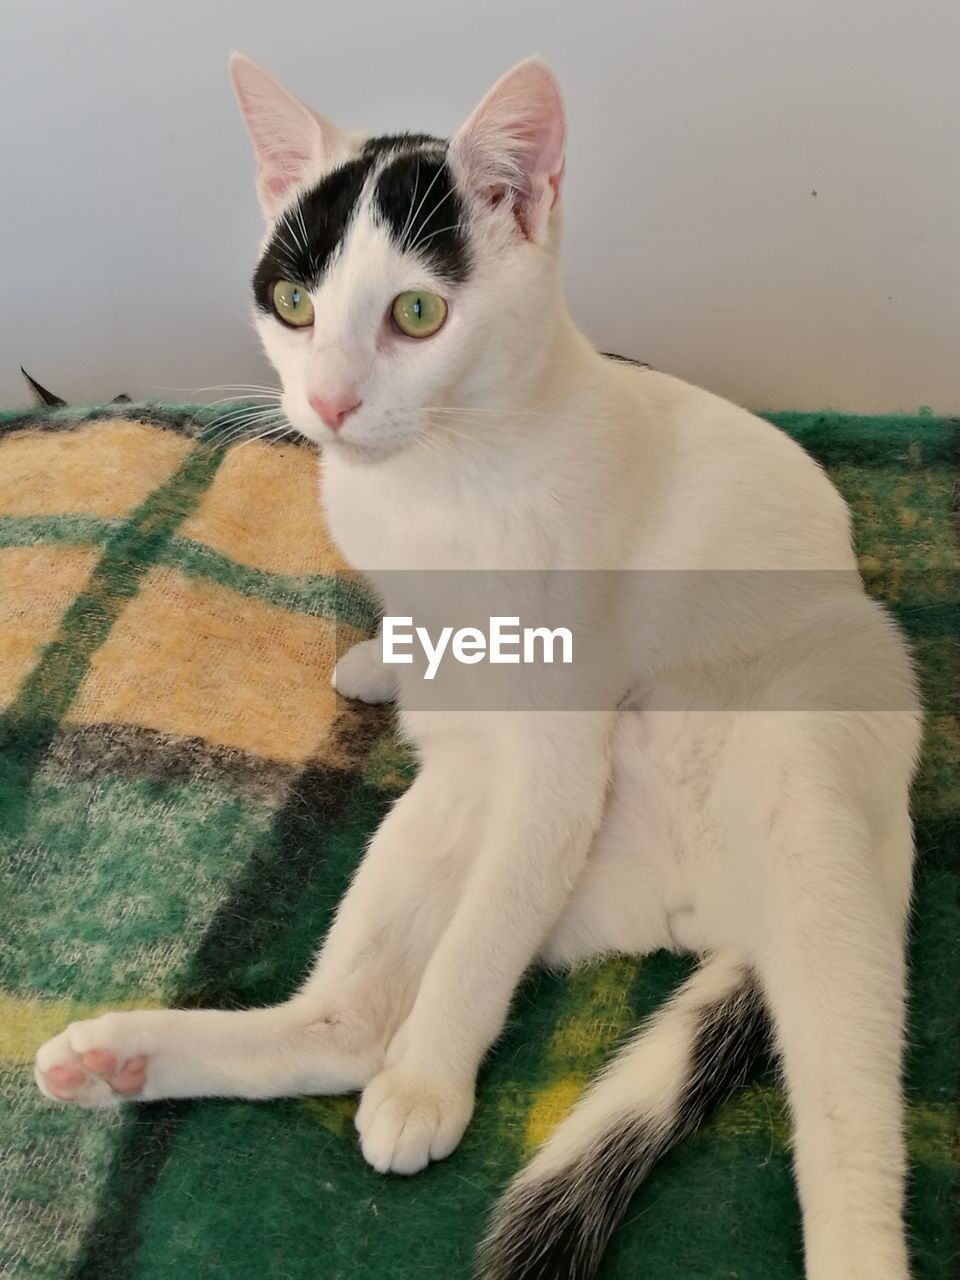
[0,406,960,1280]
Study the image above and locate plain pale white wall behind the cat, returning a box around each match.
[0,0,960,411]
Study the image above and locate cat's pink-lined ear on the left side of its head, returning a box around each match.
[230,52,351,219]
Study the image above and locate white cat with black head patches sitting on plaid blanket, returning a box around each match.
[37,54,920,1280]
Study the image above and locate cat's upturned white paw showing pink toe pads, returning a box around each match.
[33,1014,148,1107]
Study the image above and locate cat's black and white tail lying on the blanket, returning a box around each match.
[477,955,768,1280]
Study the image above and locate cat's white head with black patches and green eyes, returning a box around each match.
[230,54,566,462]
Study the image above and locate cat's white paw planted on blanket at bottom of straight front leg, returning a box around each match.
[357,1062,474,1174]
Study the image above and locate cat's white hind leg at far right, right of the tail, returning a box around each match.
[754,732,911,1280]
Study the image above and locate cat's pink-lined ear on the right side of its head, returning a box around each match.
[449,58,567,241]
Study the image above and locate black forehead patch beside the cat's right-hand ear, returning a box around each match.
[374,149,470,284]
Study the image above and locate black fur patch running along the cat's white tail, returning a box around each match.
[477,974,769,1280]
